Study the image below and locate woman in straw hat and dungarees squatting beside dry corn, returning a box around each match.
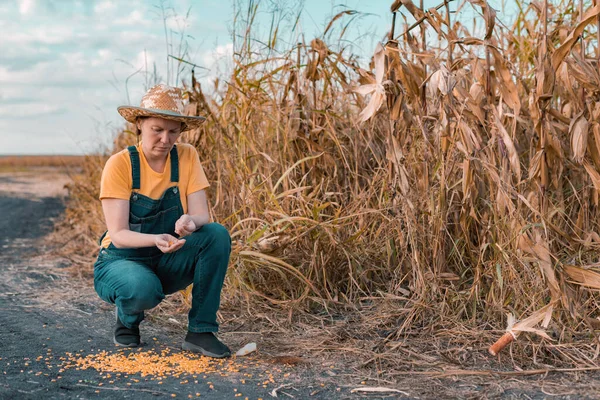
[94,85,231,358]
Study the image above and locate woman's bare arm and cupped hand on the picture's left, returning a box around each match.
[102,198,185,253]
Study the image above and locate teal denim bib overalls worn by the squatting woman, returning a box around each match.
[94,146,231,332]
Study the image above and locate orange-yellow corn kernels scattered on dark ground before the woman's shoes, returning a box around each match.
[0,345,316,400]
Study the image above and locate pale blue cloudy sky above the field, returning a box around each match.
[0,0,516,155]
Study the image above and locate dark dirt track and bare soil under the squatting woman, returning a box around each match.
[0,171,600,399]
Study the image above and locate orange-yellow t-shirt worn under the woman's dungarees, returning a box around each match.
[100,143,209,248]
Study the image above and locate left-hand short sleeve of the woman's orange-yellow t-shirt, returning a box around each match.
[100,152,132,200]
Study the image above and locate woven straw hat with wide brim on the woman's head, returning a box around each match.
[117,84,206,130]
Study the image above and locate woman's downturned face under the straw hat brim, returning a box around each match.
[137,117,182,159]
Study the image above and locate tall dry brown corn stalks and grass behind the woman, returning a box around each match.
[59,0,600,361]
